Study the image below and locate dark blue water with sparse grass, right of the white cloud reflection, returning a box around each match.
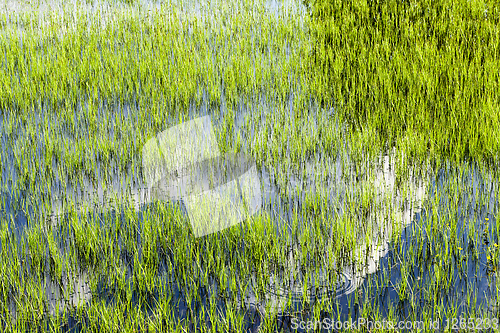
[352,165,498,327]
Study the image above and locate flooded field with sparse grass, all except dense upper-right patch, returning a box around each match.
[0,1,500,332]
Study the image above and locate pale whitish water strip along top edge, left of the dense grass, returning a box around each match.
[0,0,306,37]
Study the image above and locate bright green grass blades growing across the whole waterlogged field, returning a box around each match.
[0,1,500,332]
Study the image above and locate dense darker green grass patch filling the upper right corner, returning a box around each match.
[303,0,500,165]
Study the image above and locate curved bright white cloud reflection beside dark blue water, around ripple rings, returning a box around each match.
[236,147,426,313]
